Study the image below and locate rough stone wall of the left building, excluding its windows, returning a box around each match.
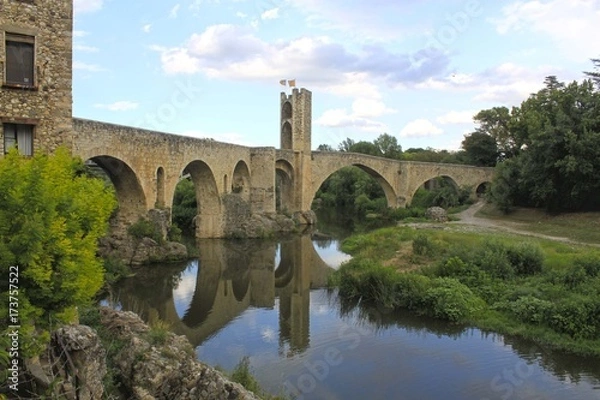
[0,0,73,157]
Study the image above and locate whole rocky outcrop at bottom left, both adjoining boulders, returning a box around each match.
[27,308,259,400]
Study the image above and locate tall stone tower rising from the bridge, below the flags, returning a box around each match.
[280,88,312,212]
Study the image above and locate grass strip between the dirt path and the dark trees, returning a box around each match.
[475,204,600,244]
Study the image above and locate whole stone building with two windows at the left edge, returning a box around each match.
[0,0,73,157]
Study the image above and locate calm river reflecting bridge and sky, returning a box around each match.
[105,230,600,400]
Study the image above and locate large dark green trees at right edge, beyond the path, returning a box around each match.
[486,76,600,213]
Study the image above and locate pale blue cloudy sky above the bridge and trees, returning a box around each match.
[73,0,600,150]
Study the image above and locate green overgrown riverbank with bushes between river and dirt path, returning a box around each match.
[330,224,600,357]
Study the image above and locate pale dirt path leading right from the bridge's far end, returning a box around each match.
[448,201,600,247]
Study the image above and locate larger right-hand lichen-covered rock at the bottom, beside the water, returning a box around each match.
[100,308,258,400]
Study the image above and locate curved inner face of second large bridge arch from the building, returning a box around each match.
[181,160,222,238]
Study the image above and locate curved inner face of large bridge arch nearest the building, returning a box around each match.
[87,155,146,223]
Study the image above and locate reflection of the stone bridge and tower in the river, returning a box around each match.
[112,235,334,353]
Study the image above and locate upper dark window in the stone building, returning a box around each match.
[5,33,35,87]
